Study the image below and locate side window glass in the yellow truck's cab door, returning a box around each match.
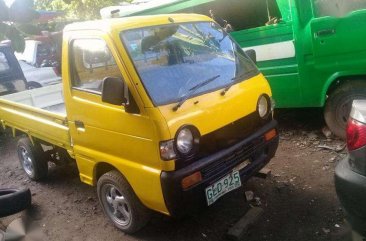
[71,39,121,94]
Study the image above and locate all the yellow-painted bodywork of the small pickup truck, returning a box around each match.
[0,15,271,214]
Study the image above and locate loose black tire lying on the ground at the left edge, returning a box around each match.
[0,188,32,218]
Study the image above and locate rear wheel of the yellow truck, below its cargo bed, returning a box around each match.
[17,137,48,181]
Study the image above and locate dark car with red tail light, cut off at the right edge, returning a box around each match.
[335,100,366,237]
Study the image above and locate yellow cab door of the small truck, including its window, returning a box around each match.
[65,35,160,198]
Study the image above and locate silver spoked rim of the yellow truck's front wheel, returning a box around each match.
[101,184,131,226]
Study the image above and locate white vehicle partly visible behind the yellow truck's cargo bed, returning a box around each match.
[19,61,61,89]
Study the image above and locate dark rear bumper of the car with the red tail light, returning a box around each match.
[335,157,366,236]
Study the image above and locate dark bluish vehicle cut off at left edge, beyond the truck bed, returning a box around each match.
[0,45,27,95]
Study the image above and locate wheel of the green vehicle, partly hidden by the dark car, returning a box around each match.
[324,80,366,139]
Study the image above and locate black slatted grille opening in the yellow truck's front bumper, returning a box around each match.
[201,137,265,179]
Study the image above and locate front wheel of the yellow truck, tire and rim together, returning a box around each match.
[97,171,150,233]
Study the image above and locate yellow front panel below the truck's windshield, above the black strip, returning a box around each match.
[158,74,272,138]
